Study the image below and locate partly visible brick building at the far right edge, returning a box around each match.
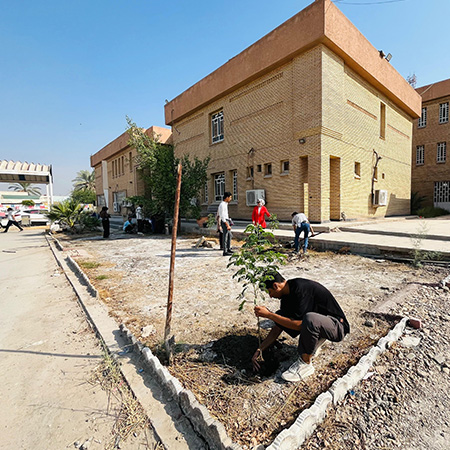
[411,79,450,211]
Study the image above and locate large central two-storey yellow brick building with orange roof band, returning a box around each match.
[165,0,421,222]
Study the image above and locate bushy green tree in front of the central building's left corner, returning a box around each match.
[127,117,209,218]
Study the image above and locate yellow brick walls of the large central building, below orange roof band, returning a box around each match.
[173,45,411,222]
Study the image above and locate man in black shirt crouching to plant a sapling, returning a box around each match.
[252,272,350,381]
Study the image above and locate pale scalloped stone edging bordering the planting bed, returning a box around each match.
[48,236,409,450]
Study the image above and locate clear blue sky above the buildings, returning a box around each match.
[0,0,450,195]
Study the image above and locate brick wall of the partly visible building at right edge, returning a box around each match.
[411,96,450,206]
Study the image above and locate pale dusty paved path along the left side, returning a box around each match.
[0,229,160,450]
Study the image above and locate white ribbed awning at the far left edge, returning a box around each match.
[0,160,52,184]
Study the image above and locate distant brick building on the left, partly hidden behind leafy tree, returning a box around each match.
[91,126,172,214]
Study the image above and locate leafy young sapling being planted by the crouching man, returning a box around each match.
[228,215,286,356]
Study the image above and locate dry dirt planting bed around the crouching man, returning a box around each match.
[59,235,446,448]
